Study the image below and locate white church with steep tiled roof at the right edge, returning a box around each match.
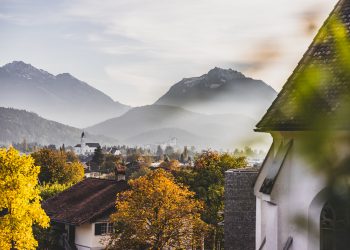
[254,0,350,250]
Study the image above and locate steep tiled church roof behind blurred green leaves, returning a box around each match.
[256,0,350,131]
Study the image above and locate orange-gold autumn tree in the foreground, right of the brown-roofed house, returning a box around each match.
[107,169,207,250]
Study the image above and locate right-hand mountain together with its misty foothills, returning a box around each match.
[87,68,276,149]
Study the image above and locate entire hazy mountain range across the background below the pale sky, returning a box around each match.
[0,61,276,148]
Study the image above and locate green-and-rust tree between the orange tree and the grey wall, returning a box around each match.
[174,150,247,249]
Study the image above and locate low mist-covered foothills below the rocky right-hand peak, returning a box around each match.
[86,105,268,149]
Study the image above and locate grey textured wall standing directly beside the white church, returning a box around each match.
[224,168,258,250]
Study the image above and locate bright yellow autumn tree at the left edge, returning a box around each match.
[0,147,50,250]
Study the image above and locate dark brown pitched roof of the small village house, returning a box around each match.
[42,178,128,225]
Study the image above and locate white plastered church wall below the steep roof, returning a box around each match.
[255,134,330,250]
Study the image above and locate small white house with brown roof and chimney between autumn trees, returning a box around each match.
[42,178,128,250]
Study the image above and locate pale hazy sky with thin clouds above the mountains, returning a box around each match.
[0,0,337,105]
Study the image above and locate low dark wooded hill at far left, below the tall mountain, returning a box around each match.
[0,107,118,146]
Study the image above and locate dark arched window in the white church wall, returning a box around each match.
[320,202,350,250]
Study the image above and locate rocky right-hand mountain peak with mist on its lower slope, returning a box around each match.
[155,67,277,117]
